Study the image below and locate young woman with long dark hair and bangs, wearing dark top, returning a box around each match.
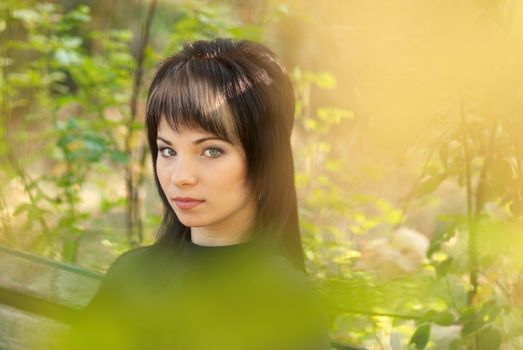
[60,39,330,350]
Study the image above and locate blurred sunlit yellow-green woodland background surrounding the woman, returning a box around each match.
[0,0,523,350]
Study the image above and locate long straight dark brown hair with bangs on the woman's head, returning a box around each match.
[146,38,305,271]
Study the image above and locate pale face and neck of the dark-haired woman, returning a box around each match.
[156,119,256,245]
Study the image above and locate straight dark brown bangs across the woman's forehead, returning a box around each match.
[147,60,240,144]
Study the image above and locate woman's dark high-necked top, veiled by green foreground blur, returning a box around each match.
[59,237,330,350]
